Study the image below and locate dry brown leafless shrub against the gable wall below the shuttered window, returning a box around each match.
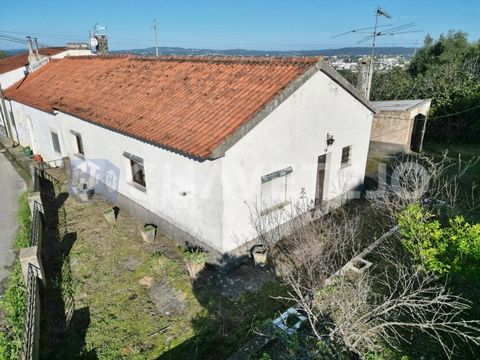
[251,193,361,336]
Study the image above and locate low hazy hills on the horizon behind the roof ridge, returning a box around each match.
[112,47,414,57]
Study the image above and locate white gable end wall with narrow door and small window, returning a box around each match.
[219,72,373,251]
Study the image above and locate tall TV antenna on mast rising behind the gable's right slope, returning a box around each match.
[331,6,421,99]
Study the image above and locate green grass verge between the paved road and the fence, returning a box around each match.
[0,192,31,360]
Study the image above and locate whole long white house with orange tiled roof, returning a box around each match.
[6,56,375,253]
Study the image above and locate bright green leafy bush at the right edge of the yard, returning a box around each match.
[398,204,480,274]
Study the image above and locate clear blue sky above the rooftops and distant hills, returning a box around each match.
[0,0,480,50]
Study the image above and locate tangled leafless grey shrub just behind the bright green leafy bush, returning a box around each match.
[367,152,479,227]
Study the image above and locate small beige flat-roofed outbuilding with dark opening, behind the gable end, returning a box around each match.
[371,99,431,152]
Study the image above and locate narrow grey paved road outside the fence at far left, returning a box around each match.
[0,150,26,294]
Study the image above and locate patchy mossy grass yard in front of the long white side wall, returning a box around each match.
[42,197,287,359]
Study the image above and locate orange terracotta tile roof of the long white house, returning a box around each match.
[6,56,318,159]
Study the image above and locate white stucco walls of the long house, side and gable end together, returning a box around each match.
[5,67,372,252]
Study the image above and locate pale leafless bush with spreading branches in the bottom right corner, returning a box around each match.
[315,264,480,358]
